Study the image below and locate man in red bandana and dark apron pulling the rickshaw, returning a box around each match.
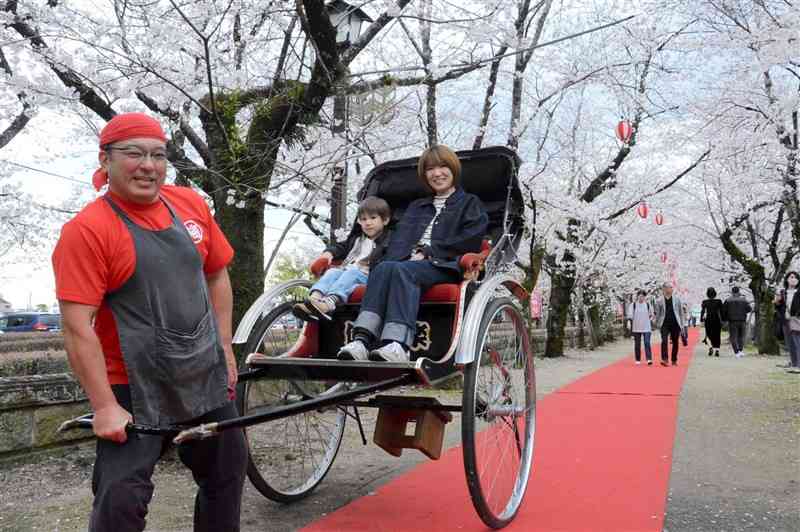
[53,113,247,532]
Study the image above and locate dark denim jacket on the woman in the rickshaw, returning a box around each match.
[384,188,489,272]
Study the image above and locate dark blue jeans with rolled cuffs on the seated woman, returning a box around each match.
[354,260,460,346]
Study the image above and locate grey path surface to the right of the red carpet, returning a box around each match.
[664,334,800,532]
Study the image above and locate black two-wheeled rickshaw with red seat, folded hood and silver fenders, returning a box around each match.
[62,147,536,528]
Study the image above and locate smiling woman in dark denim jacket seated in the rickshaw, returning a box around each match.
[338,145,489,362]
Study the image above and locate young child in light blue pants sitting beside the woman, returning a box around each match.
[292,196,391,321]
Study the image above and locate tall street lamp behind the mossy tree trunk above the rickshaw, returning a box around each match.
[326,0,372,242]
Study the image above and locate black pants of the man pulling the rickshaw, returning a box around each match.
[89,385,247,532]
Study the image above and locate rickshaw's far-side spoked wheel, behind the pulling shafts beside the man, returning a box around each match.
[238,301,346,503]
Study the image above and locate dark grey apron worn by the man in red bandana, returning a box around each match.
[104,196,229,426]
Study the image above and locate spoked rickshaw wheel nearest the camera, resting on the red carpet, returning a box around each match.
[461,298,536,528]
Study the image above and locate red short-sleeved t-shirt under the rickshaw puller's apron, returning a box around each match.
[53,185,233,384]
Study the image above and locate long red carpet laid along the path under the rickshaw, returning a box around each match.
[303,330,698,532]
